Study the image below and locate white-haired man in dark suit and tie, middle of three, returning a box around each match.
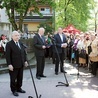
[33,27,46,80]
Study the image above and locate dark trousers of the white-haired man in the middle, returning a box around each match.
[36,56,45,76]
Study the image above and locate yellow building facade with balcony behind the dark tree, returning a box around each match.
[15,5,53,33]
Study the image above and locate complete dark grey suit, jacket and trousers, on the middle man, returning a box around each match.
[33,34,45,76]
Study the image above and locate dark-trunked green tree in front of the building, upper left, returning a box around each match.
[0,0,53,31]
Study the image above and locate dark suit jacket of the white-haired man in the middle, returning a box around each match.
[33,34,45,56]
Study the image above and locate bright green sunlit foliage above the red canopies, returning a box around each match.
[56,0,90,31]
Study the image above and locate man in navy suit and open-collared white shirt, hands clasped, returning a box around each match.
[54,28,67,75]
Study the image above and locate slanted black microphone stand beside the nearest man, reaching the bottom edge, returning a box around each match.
[24,46,41,98]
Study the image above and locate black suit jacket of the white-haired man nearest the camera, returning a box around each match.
[6,40,26,68]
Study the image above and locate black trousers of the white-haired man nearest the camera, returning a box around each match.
[9,68,23,92]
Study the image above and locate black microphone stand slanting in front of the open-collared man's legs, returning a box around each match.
[51,38,69,87]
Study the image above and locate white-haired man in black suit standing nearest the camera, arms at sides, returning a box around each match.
[6,31,28,96]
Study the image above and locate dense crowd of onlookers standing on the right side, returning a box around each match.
[62,32,98,77]
